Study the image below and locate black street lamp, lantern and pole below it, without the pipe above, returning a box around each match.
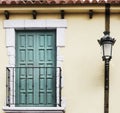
[98,32,115,113]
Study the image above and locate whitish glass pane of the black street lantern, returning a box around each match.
[103,43,112,57]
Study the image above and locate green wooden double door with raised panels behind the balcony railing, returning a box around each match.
[15,31,56,107]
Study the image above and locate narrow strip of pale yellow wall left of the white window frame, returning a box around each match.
[0,15,8,113]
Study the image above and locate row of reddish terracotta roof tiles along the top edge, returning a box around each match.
[0,0,120,5]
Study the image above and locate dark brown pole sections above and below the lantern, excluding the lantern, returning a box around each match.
[104,4,110,113]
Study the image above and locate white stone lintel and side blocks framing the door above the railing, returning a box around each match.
[4,19,67,67]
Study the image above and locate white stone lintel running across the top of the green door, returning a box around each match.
[4,19,67,29]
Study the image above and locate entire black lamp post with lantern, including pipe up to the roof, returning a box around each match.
[98,3,115,113]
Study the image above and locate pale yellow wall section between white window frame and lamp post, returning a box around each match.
[63,15,104,113]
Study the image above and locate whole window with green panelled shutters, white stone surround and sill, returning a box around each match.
[3,20,67,113]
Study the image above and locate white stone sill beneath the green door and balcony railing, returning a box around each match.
[3,106,65,113]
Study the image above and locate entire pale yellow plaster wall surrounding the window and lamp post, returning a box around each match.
[0,5,120,113]
